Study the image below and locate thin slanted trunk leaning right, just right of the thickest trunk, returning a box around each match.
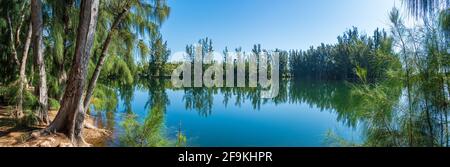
[83,4,130,111]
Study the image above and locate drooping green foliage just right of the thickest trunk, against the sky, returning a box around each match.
[94,0,170,84]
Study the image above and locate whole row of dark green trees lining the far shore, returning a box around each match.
[156,27,401,82]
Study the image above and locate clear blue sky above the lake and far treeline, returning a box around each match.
[161,0,401,60]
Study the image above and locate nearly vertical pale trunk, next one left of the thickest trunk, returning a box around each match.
[31,0,49,125]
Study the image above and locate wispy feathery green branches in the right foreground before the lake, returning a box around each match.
[326,4,450,147]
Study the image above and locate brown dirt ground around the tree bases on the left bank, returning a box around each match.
[0,106,110,147]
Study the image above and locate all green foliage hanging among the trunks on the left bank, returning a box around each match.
[0,0,170,128]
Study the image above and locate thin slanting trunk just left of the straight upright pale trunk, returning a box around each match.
[16,24,33,120]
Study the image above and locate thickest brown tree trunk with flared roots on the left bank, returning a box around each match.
[46,0,99,146]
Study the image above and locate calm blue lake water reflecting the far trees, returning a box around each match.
[91,80,370,146]
